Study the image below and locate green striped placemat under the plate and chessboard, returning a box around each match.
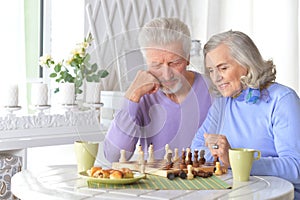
[88,175,231,190]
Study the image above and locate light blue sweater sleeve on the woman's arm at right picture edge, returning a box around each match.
[251,91,300,184]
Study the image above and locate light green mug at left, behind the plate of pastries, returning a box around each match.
[74,141,99,172]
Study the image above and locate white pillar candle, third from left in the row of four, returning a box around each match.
[59,83,75,105]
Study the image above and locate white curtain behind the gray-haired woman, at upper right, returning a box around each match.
[192,0,300,94]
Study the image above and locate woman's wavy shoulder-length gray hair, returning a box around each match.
[203,30,276,94]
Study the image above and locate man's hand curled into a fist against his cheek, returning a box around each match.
[125,70,160,102]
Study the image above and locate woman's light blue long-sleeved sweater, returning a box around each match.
[191,83,300,199]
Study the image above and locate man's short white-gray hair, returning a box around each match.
[139,18,191,58]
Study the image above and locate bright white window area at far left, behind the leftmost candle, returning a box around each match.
[0,0,27,112]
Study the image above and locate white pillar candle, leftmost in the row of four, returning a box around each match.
[4,84,19,107]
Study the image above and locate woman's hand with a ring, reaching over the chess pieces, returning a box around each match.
[204,133,231,168]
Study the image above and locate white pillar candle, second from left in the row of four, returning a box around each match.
[31,83,48,106]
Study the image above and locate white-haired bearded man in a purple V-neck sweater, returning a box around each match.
[104,18,211,162]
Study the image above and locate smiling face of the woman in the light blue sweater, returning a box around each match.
[205,44,247,97]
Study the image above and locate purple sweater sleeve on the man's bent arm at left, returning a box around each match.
[104,98,139,162]
